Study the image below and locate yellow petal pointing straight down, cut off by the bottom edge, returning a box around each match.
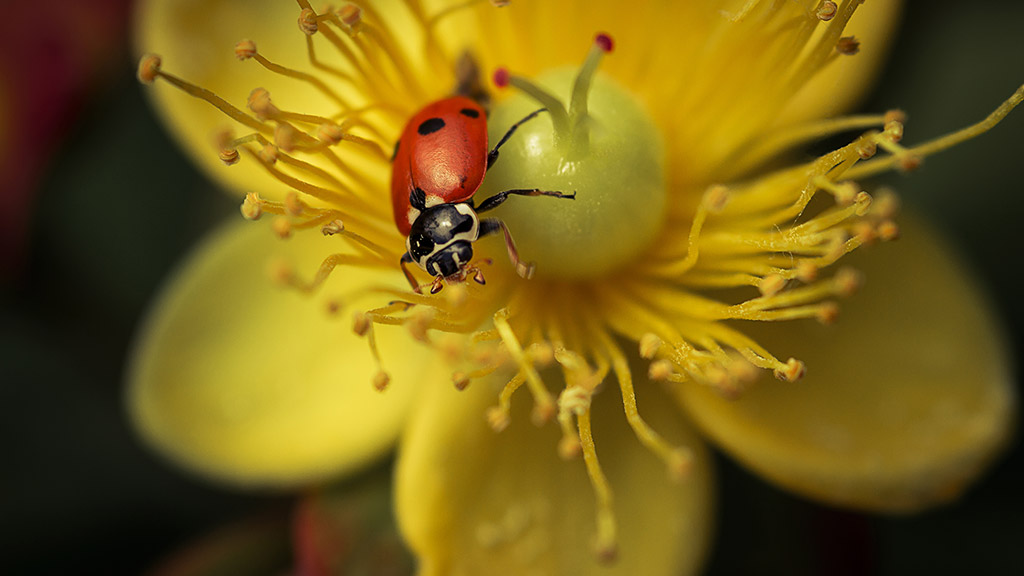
[396,373,713,576]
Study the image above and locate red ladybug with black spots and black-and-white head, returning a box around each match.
[391,96,575,293]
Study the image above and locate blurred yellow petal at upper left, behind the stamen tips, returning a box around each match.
[135,0,329,198]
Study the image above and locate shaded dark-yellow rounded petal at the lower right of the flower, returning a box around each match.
[681,218,1016,511]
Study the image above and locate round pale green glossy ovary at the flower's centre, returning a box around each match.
[477,70,666,279]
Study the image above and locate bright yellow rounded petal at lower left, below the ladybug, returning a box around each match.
[128,222,432,486]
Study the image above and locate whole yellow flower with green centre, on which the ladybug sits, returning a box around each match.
[130,0,1024,574]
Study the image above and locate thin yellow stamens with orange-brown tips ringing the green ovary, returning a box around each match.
[138,0,1024,560]
